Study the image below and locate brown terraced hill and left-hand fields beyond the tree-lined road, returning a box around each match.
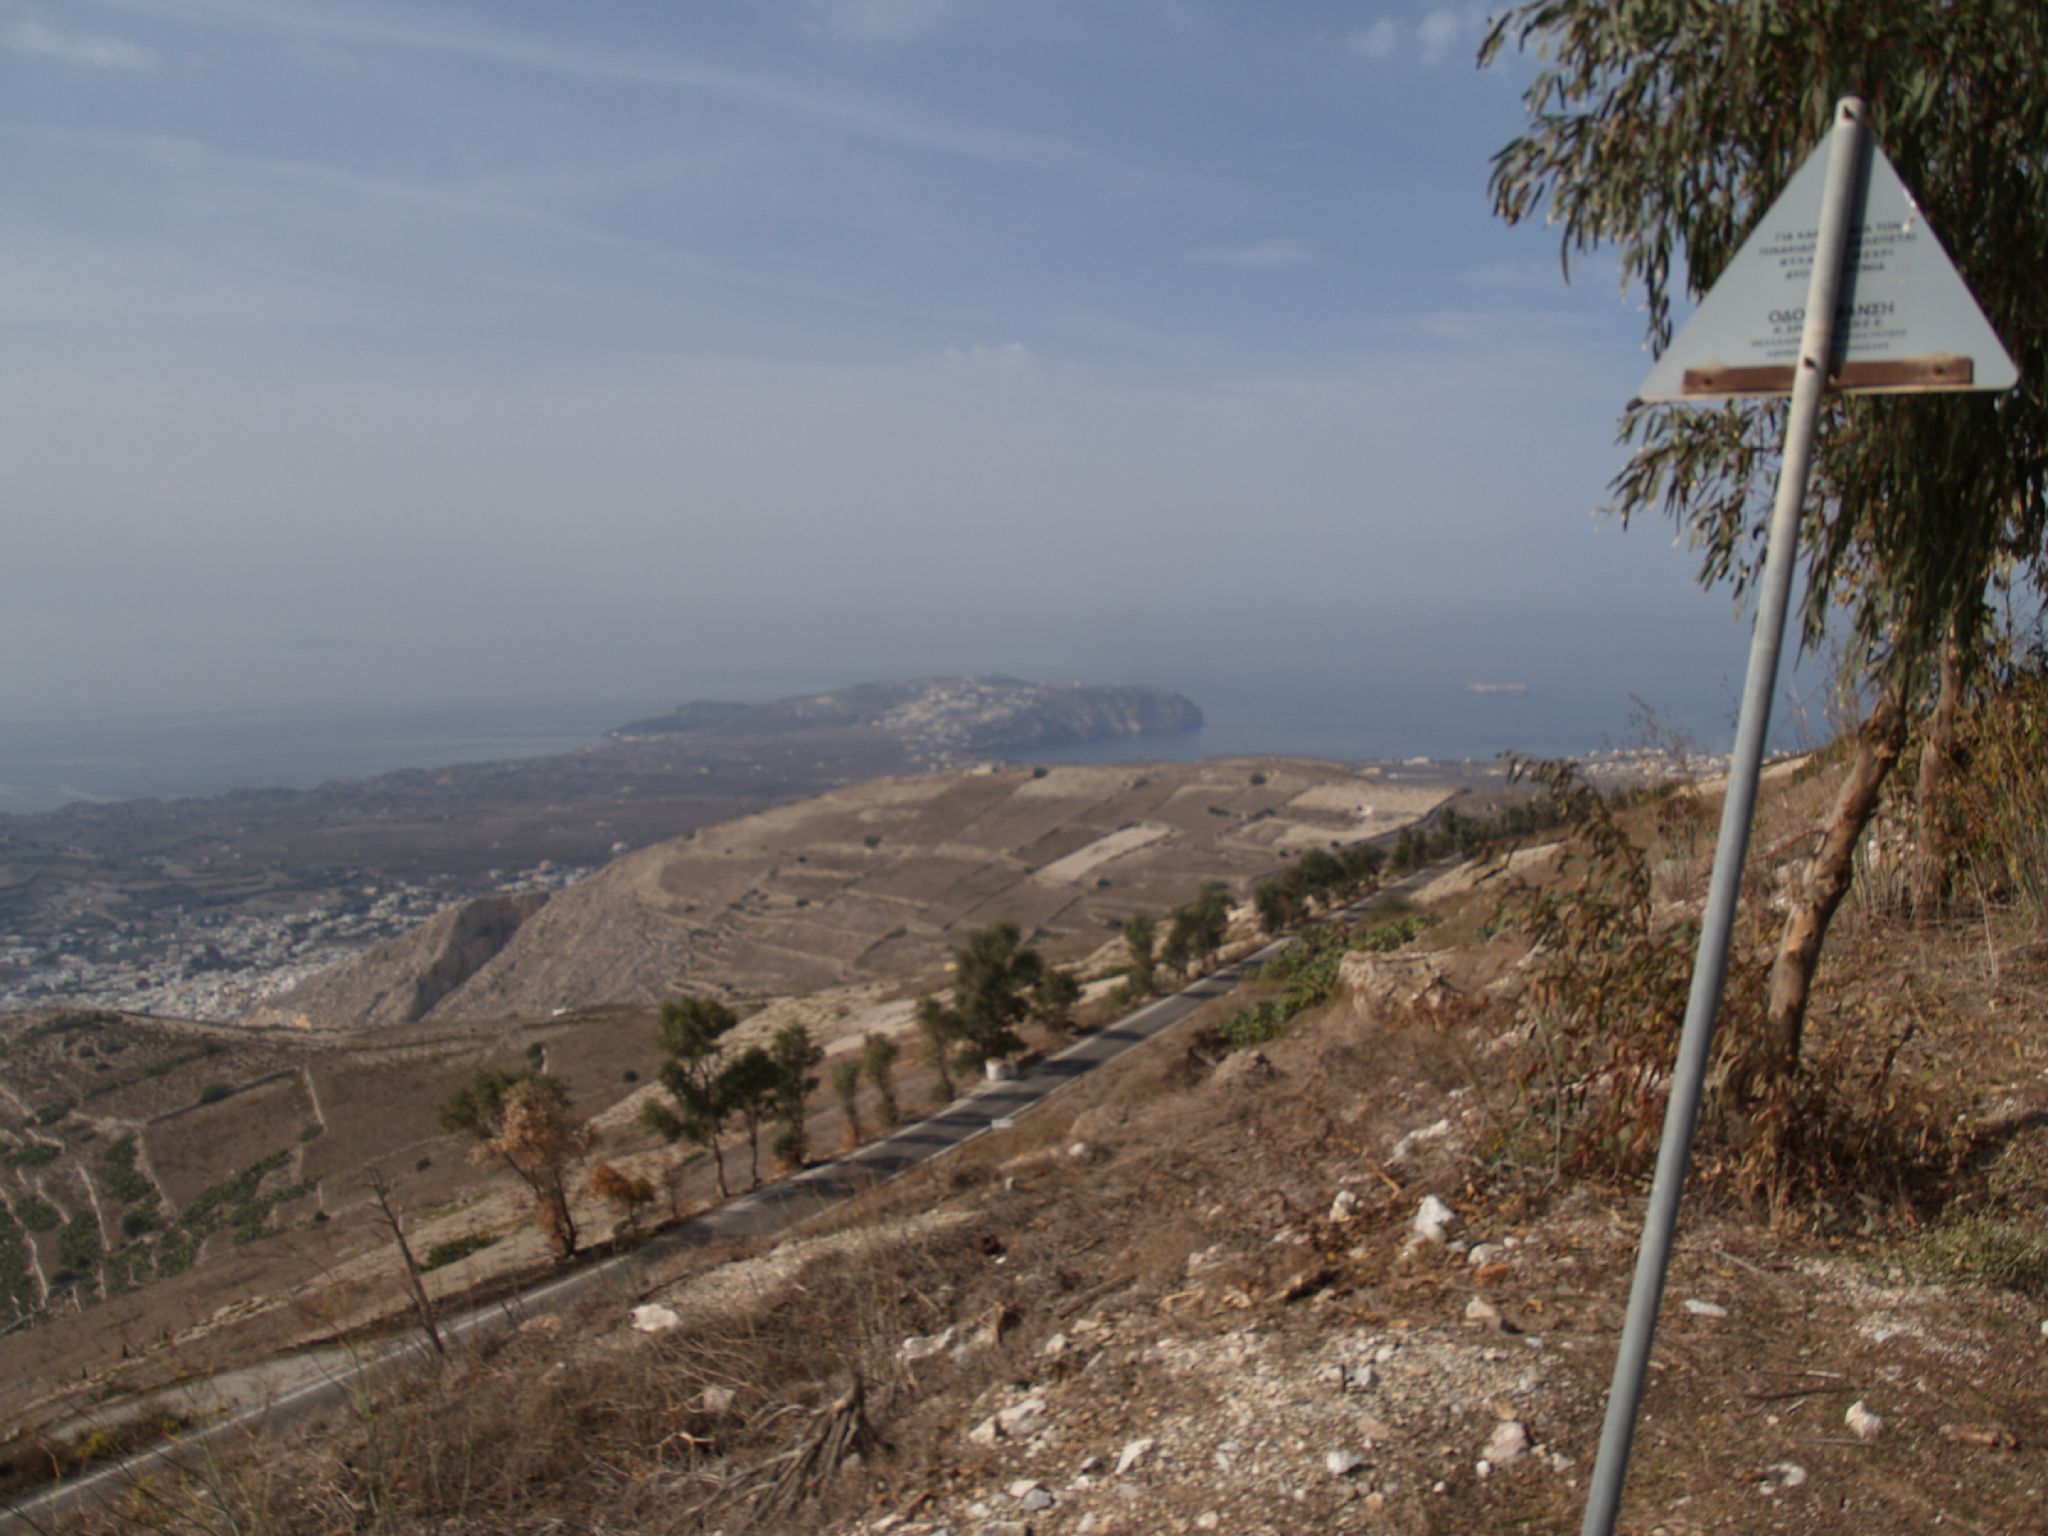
[0,762,1450,1427]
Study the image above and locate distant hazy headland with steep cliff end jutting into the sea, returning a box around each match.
[612,676,1202,756]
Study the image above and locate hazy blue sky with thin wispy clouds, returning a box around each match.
[0,0,1741,713]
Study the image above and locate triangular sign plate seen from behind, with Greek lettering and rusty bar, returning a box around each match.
[1638,129,2019,399]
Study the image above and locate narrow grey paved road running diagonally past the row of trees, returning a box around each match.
[0,860,1458,1532]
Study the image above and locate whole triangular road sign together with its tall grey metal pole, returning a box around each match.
[1581,96,2017,1536]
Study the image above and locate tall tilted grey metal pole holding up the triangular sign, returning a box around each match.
[1579,96,1864,1536]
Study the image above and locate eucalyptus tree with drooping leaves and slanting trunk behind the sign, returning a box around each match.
[1490,0,2048,1075]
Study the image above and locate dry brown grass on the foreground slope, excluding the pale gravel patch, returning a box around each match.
[28,720,2048,1536]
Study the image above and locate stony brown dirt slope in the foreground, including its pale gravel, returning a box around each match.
[48,761,2048,1536]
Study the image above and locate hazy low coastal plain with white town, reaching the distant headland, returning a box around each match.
[0,678,1202,1020]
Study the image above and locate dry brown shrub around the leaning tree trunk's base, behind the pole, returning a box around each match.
[1501,764,1958,1227]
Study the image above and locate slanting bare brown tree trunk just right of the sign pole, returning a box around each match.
[1763,684,1907,1077]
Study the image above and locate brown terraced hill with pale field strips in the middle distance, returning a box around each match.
[254,760,1446,1028]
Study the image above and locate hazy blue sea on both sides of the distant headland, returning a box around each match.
[0,653,1825,813]
